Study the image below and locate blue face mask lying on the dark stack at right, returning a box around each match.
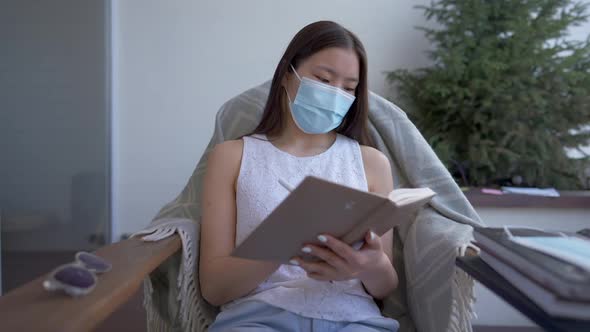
[504,226,590,271]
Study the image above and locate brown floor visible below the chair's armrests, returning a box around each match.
[0,252,542,332]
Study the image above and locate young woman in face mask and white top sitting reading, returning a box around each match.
[199,21,398,331]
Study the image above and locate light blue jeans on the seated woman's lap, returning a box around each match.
[209,301,399,332]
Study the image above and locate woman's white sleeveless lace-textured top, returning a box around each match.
[222,135,381,321]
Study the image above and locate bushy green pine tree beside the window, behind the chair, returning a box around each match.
[388,0,590,189]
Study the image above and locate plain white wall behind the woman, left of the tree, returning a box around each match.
[112,0,429,239]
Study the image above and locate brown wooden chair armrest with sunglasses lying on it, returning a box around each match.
[0,235,181,332]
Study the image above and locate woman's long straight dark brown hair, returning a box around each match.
[252,21,373,146]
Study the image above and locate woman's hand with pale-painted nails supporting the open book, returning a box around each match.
[290,232,391,281]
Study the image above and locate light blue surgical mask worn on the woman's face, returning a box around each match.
[287,66,355,134]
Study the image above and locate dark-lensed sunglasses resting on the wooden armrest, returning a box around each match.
[43,251,112,296]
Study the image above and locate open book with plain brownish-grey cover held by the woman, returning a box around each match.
[232,176,435,262]
